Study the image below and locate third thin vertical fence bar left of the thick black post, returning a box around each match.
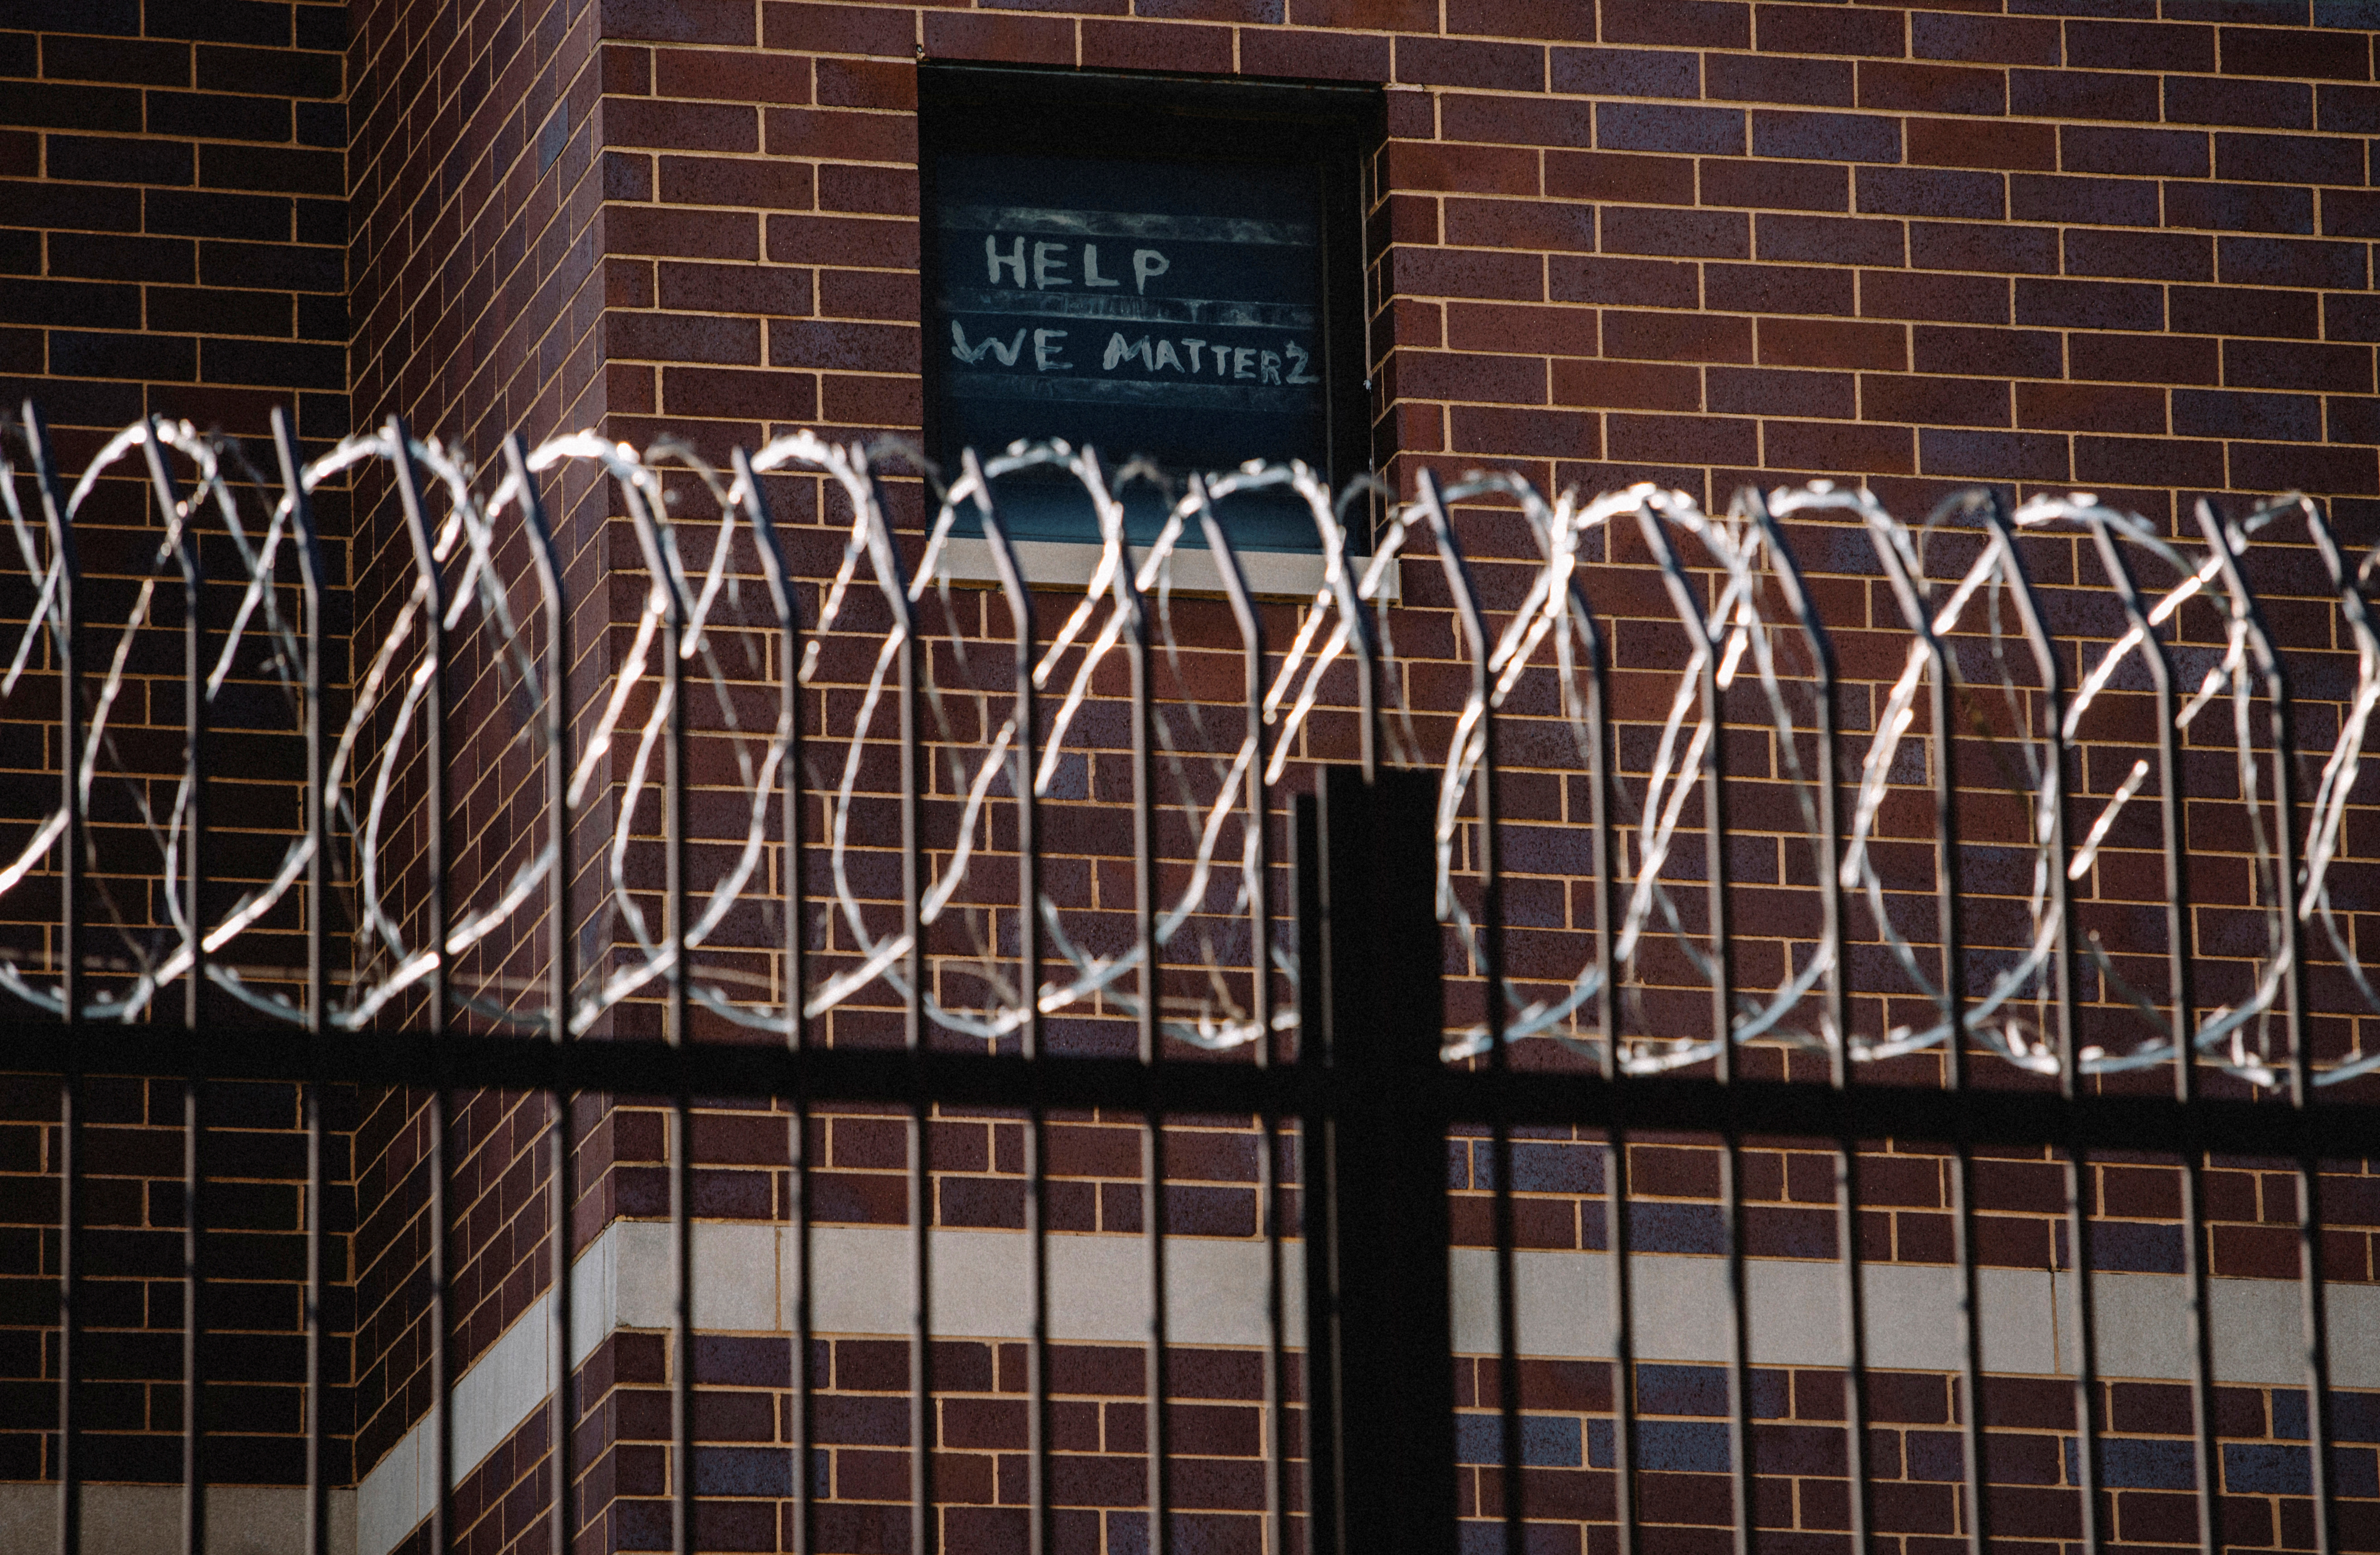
[961,474,1057,1555]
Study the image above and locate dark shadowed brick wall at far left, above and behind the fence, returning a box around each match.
[0,0,352,1486]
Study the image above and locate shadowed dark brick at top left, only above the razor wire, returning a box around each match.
[0,0,347,464]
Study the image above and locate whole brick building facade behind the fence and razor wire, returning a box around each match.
[0,0,2380,1555]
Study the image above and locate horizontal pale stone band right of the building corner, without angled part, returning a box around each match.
[576,1222,2380,1381]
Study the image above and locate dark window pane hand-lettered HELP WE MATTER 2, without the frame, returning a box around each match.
[926,152,1328,540]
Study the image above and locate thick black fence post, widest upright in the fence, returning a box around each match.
[1297,767,1457,1555]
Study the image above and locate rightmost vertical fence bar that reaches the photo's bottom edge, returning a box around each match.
[2197,498,2337,1555]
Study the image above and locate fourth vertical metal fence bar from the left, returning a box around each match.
[383,417,455,1555]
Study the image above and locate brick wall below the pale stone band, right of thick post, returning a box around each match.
[1457,1360,2380,1555]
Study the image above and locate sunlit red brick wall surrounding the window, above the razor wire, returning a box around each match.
[602,0,2380,529]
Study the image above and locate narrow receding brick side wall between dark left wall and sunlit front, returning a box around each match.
[347,0,614,1495]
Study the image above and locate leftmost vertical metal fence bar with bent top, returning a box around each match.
[24,400,88,1555]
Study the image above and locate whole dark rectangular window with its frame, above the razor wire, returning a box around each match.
[919,64,1380,581]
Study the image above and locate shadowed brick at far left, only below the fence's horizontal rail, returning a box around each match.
[0,1076,355,1486]
